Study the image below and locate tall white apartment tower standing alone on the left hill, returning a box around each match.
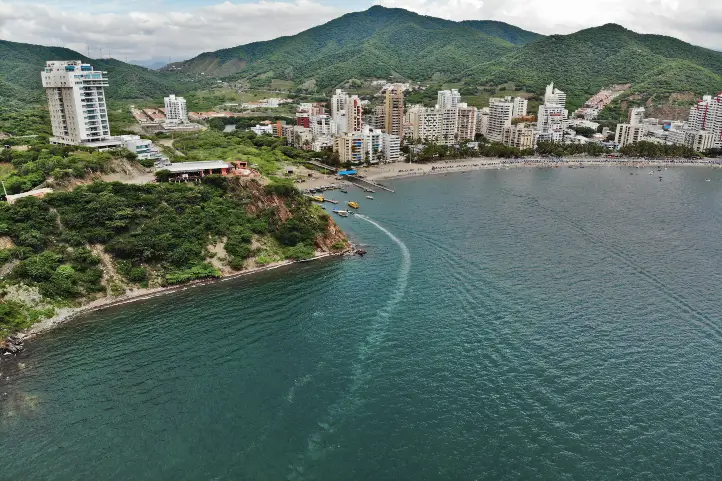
[41,60,111,146]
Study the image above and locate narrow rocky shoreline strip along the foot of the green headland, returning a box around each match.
[15,251,349,341]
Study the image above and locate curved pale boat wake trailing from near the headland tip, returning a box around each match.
[287,214,411,480]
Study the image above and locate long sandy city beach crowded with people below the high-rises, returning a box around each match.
[358,157,722,181]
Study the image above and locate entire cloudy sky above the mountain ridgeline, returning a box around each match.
[0,0,722,61]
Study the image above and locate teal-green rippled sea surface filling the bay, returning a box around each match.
[0,168,722,481]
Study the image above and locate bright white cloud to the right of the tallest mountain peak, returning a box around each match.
[376,0,722,50]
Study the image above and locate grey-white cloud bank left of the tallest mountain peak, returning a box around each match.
[0,0,344,60]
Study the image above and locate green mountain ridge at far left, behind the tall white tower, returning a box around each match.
[0,40,187,107]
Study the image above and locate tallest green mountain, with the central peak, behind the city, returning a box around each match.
[168,6,536,88]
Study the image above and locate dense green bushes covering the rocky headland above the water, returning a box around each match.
[0,176,339,331]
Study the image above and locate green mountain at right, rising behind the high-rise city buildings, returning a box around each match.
[460,24,722,107]
